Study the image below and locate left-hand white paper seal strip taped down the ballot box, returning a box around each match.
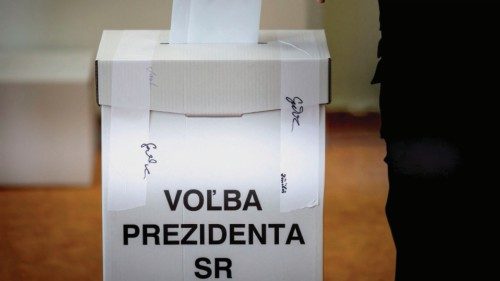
[107,31,160,211]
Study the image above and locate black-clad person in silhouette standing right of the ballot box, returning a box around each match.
[373,0,500,281]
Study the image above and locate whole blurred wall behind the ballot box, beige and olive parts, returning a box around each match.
[0,0,379,114]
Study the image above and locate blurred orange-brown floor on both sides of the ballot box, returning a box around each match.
[0,114,394,281]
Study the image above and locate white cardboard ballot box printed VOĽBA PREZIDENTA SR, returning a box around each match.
[96,31,330,281]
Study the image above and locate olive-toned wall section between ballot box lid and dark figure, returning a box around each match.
[324,0,380,113]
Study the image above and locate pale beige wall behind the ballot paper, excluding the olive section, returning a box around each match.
[0,0,322,50]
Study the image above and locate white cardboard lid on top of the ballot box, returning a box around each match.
[96,30,331,116]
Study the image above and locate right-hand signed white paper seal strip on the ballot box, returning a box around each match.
[278,31,320,212]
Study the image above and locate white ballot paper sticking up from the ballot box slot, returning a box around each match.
[170,0,262,44]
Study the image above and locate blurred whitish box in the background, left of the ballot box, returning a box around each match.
[0,50,96,186]
